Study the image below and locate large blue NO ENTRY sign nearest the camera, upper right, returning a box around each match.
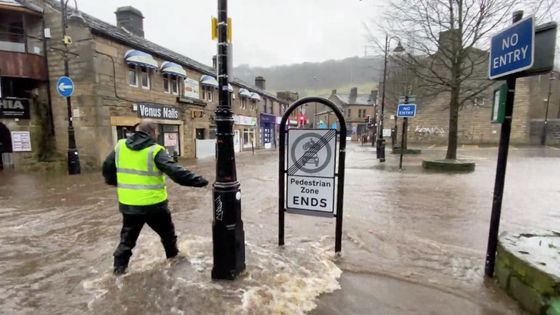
[488,16,535,79]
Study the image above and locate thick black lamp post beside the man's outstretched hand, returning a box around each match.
[212,0,245,280]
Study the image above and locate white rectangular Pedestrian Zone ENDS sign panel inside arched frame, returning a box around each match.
[286,129,336,214]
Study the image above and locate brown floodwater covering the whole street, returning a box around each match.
[0,144,560,314]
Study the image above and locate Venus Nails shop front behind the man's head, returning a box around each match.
[111,103,184,156]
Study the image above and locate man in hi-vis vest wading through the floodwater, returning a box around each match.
[103,121,208,275]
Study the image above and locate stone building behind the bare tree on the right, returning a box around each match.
[385,30,560,145]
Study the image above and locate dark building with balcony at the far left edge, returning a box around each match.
[0,0,56,169]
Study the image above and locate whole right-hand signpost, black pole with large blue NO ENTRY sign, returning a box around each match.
[484,11,556,277]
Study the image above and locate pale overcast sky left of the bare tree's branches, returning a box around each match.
[77,0,385,66]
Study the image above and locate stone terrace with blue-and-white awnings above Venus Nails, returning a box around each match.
[0,0,287,169]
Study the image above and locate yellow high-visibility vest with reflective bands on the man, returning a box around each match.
[115,139,167,206]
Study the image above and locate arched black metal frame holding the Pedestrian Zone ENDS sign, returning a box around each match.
[278,97,346,253]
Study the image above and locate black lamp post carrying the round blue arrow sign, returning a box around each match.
[62,0,81,175]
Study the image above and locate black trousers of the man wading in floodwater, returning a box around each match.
[113,204,179,268]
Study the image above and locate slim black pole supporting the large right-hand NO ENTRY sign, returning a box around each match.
[484,11,523,278]
